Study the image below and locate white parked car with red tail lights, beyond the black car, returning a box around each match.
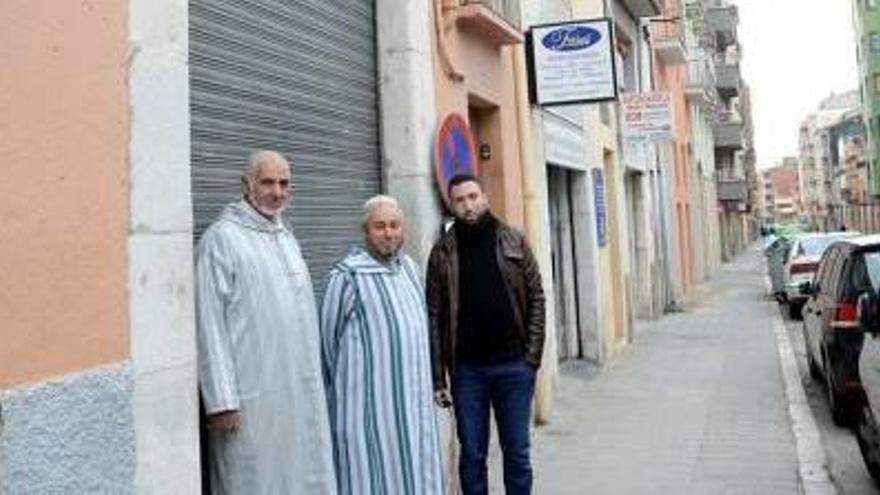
[782,232,861,318]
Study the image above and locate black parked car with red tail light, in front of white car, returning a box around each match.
[801,236,880,426]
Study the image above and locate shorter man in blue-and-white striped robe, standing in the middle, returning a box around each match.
[321,196,443,495]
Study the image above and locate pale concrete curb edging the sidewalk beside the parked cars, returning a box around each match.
[772,304,837,495]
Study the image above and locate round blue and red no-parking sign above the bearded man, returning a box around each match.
[434,113,479,205]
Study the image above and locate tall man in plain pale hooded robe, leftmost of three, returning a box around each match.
[196,151,336,495]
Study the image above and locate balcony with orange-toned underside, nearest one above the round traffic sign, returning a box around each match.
[455,0,523,46]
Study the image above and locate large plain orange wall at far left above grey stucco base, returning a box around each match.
[0,0,129,388]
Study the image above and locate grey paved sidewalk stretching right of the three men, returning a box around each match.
[524,250,802,495]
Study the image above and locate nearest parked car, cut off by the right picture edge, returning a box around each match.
[855,235,880,483]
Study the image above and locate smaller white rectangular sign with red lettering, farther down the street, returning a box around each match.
[620,91,675,142]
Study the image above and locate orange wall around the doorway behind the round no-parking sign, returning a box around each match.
[433,9,525,228]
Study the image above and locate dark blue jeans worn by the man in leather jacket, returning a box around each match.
[451,359,535,495]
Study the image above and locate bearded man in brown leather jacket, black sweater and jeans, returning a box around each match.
[426,175,544,495]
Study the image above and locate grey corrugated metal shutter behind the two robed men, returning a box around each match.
[189,0,381,291]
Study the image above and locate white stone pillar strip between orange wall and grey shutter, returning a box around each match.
[128,0,201,493]
